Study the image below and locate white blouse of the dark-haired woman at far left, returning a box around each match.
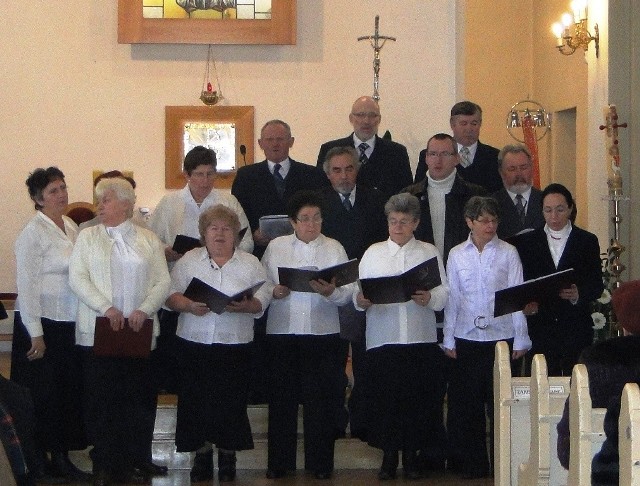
[15,211,78,337]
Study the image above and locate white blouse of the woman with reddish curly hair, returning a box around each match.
[169,248,273,344]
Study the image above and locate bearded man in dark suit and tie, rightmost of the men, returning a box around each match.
[493,144,544,239]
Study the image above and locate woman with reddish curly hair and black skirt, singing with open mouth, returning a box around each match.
[167,204,271,482]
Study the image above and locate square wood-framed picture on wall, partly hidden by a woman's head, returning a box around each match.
[164,106,254,189]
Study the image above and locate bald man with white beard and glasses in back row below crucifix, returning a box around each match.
[317,96,412,199]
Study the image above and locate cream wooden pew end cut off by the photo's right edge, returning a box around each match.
[618,383,640,486]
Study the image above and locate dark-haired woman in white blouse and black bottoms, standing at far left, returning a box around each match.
[11,167,89,482]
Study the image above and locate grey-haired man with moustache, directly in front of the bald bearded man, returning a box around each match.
[321,146,388,440]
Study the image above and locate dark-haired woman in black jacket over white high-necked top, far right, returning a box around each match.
[518,184,604,376]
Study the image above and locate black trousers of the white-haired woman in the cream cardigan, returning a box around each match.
[83,347,155,472]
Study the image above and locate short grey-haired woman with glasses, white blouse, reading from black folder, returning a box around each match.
[354,193,449,480]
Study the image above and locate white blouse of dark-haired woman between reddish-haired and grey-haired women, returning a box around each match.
[262,233,356,335]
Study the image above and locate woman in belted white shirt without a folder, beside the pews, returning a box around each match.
[443,196,531,479]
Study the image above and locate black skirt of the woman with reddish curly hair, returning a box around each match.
[176,338,253,452]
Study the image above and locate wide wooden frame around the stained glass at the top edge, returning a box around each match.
[118,0,296,44]
